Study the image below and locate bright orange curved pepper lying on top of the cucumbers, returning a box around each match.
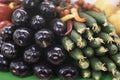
[70,7,86,22]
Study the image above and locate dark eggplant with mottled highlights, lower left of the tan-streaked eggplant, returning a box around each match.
[23,45,41,63]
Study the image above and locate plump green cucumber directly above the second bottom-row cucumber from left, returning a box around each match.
[90,57,107,71]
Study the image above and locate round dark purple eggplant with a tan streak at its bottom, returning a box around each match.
[35,29,54,48]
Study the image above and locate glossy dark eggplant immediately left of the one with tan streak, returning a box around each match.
[13,28,32,46]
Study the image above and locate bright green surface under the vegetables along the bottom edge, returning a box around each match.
[0,72,112,80]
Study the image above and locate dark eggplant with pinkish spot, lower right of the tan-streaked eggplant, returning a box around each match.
[47,46,65,65]
